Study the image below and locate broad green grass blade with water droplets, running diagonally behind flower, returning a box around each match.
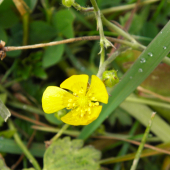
[78,22,170,139]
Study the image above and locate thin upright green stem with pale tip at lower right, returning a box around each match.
[130,113,155,170]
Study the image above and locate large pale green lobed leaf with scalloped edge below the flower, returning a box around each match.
[43,137,101,170]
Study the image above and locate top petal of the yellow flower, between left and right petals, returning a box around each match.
[60,74,89,95]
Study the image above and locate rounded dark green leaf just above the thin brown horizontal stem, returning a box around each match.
[52,9,74,38]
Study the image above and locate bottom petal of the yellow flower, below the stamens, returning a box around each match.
[61,106,102,126]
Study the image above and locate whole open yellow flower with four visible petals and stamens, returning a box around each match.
[42,74,108,125]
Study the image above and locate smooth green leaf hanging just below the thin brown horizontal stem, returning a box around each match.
[42,38,64,68]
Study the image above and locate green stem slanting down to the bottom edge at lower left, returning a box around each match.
[8,119,41,170]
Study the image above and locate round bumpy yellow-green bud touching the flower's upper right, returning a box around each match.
[102,70,119,87]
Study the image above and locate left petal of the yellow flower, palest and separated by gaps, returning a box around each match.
[42,86,74,113]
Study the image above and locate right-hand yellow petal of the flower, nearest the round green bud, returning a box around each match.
[87,75,109,104]
